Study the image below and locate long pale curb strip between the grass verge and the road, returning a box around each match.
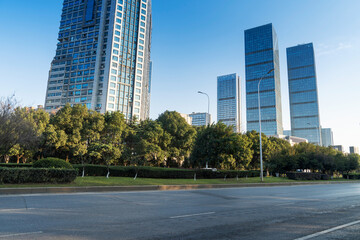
[0,181,360,195]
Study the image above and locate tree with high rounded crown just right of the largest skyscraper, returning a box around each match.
[156,111,196,166]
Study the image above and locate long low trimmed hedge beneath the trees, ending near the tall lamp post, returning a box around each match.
[73,164,260,179]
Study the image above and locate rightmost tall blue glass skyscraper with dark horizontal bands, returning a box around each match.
[286,43,321,145]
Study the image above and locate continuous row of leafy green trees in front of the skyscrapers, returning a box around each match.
[0,98,358,173]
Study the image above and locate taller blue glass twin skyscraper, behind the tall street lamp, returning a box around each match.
[245,24,283,135]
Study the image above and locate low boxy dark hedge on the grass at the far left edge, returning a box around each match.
[0,168,77,184]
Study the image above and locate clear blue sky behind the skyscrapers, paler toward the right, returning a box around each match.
[0,0,360,150]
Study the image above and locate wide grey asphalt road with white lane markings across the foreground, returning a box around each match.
[0,184,360,240]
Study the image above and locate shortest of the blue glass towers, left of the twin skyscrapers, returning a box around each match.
[217,73,241,132]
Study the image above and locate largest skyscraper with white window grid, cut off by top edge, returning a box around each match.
[45,0,151,119]
